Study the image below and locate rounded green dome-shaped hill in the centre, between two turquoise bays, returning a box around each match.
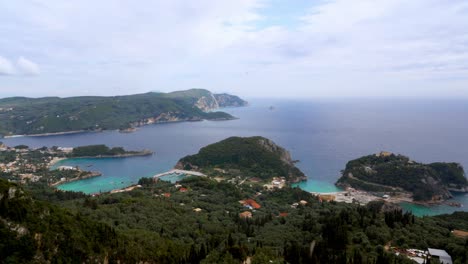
[176,137,307,182]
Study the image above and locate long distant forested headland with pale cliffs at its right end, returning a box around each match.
[0,89,247,136]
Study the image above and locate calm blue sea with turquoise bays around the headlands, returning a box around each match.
[2,98,468,216]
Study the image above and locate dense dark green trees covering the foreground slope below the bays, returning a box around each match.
[0,177,468,264]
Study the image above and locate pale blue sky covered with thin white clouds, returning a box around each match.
[0,0,468,98]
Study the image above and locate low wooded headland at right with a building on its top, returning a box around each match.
[337,152,468,201]
